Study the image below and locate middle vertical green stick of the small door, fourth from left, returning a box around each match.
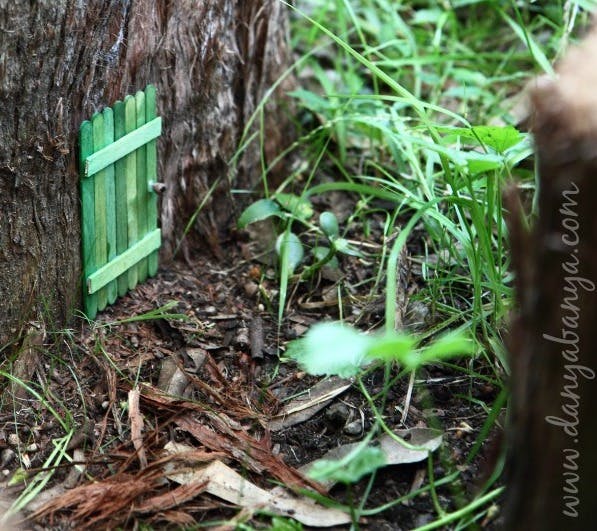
[113,101,129,296]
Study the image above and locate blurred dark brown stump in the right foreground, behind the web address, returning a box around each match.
[505,26,597,531]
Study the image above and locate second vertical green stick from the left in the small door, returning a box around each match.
[91,113,108,311]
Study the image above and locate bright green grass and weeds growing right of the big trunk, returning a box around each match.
[234,0,597,529]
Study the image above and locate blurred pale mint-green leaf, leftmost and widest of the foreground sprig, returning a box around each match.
[286,323,375,378]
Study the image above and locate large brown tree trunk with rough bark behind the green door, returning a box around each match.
[0,0,289,345]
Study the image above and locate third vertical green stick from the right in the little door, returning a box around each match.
[124,96,139,289]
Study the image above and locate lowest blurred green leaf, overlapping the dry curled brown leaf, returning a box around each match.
[309,446,386,485]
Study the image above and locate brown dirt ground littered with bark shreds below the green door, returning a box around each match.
[0,223,506,530]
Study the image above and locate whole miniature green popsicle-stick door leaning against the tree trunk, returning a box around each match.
[79,85,161,319]
